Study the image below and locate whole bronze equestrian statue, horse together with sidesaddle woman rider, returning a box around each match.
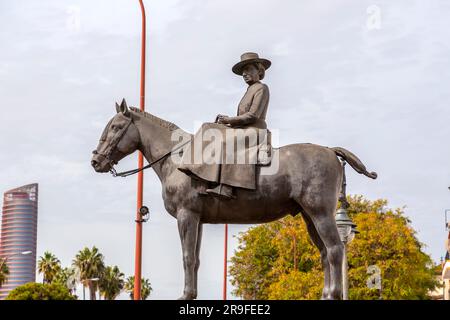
[91,52,377,300]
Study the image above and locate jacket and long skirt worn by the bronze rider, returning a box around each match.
[179,82,270,189]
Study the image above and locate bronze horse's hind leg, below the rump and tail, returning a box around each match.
[302,197,344,299]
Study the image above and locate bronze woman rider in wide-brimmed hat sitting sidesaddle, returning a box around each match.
[178,52,271,199]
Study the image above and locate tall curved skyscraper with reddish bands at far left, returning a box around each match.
[0,183,38,300]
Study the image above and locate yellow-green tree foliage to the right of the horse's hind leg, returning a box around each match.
[348,199,437,300]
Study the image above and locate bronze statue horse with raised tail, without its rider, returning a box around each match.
[91,100,377,299]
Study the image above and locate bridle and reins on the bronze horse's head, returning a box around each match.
[92,118,191,178]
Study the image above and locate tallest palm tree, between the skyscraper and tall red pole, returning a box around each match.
[72,246,105,300]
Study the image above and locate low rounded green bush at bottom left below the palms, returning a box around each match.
[6,282,75,300]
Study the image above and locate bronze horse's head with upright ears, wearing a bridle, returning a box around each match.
[91,99,140,172]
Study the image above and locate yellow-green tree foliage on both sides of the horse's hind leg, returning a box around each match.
[230,196,437,299]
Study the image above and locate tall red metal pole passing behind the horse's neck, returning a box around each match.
[133,0,146,300]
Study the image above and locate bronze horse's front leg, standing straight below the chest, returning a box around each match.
[177,209,200,300]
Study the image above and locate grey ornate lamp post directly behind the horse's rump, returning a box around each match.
[335,161,359,300]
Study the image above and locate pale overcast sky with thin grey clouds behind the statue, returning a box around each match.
[0,0,450,299]
